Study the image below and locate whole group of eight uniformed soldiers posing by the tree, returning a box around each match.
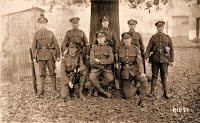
[32,15,174,106]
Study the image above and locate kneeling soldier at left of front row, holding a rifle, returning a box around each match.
[61,43,87,99]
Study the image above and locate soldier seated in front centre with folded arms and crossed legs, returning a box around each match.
[89,31,114,98]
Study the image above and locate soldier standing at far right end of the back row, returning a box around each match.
[145,21,174,99]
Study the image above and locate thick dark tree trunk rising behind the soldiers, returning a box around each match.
[89,0,120,42]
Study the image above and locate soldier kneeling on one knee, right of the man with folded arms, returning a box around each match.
[119,32,147,106]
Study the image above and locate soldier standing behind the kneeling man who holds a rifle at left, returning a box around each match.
[61,17,89,65]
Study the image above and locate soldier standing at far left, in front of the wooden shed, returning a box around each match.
[32,14,60,96]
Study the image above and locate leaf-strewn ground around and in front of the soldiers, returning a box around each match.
[0,38,200,123]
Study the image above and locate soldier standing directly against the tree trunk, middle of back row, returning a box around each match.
[92,16,119,89]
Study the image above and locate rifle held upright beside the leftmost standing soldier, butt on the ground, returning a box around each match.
[29,48,37,95]
